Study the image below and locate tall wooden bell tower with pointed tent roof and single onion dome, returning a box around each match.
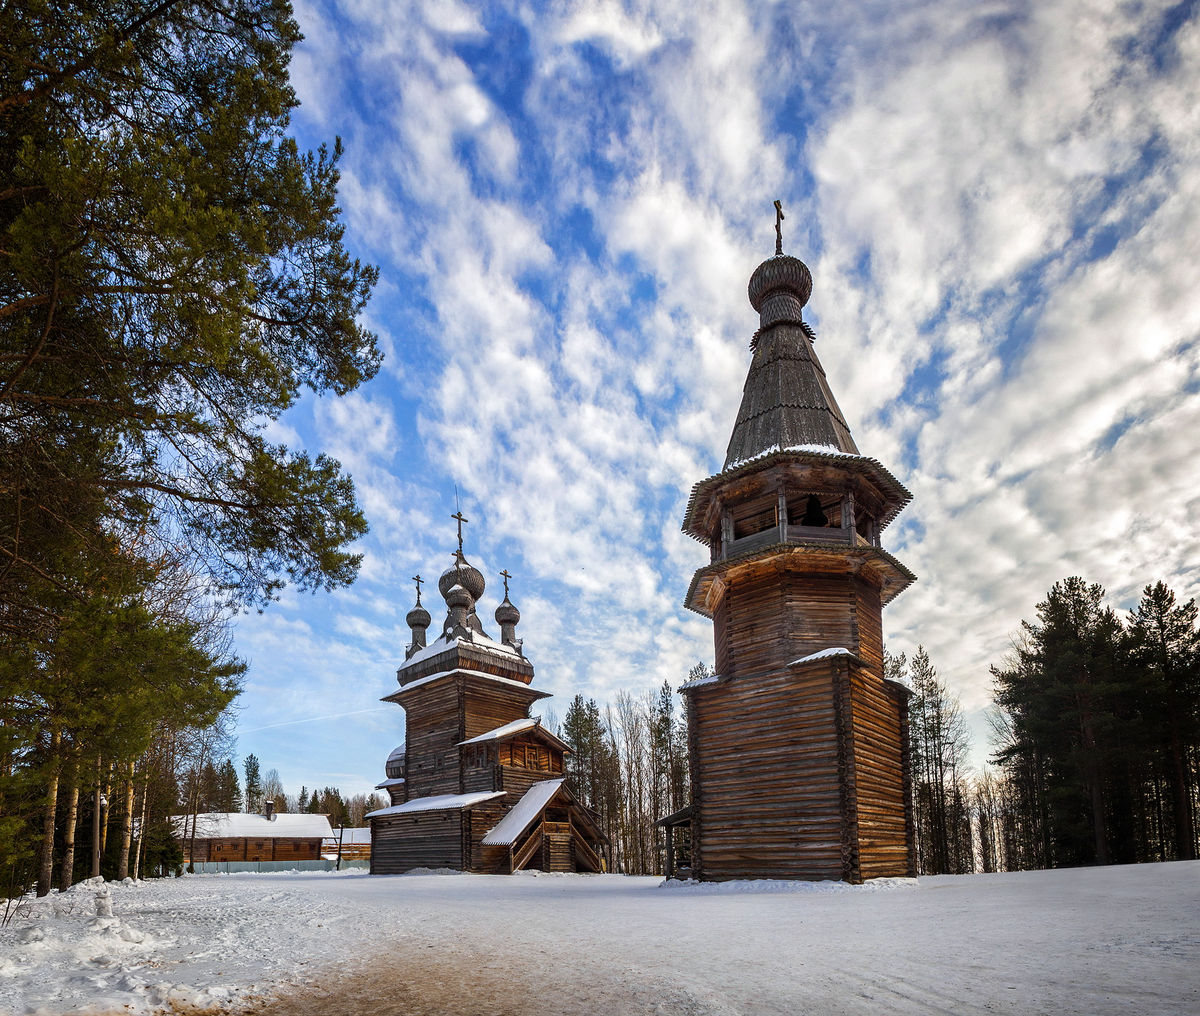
[660,214,916,883]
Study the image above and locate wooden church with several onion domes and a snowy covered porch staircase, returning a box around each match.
[367,512,608,874]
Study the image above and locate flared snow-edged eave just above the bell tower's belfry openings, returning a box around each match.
[683,444,912,545]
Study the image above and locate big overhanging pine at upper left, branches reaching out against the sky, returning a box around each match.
[0,0,379,631]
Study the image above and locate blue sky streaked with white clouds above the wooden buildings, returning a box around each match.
[226,0,1200,793]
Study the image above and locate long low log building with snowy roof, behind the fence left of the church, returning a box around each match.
[170,812,334,864]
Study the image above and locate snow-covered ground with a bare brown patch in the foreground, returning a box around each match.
[0,862,1200,1016]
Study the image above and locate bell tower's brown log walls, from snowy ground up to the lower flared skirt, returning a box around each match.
[689,544,911,882]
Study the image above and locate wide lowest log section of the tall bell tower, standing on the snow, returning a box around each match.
[688,650,916,883]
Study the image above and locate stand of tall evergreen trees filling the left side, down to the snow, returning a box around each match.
[0,0,379,896]
